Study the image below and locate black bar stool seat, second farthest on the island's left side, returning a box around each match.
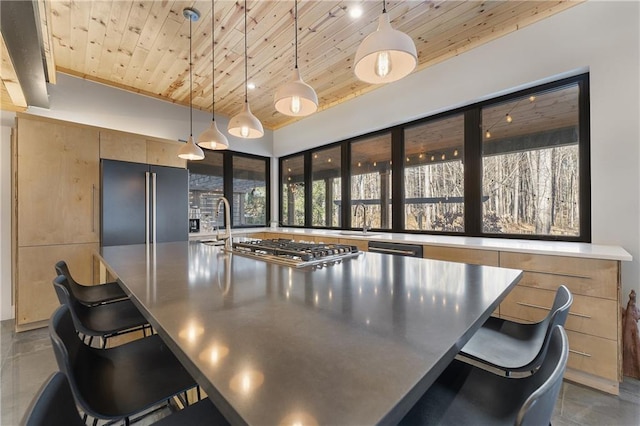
[53,275,151,347]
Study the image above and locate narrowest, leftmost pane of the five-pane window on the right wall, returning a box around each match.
[280,155,305,226]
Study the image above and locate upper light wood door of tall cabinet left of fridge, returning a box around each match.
[17,118,100,246]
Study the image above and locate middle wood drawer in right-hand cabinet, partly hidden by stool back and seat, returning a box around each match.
[500,284,618,340]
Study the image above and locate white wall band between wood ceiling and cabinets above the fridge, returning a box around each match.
[27,73,273,156]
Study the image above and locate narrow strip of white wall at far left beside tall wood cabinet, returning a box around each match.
[0,111,15,321]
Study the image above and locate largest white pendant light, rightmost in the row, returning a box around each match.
[354,0,418,84]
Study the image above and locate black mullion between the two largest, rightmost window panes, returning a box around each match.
[463,107,482,236]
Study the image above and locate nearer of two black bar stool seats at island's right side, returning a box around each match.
[400,325,569,426]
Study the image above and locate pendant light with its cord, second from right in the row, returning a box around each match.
[275,0,318,117]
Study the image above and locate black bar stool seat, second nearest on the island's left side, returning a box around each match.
[49,305,196,424]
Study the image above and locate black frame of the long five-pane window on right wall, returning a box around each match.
[278,72,591,243]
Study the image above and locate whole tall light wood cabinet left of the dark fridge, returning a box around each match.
[14,115,100,330]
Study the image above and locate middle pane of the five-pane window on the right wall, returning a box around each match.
[351,133,393,229]
